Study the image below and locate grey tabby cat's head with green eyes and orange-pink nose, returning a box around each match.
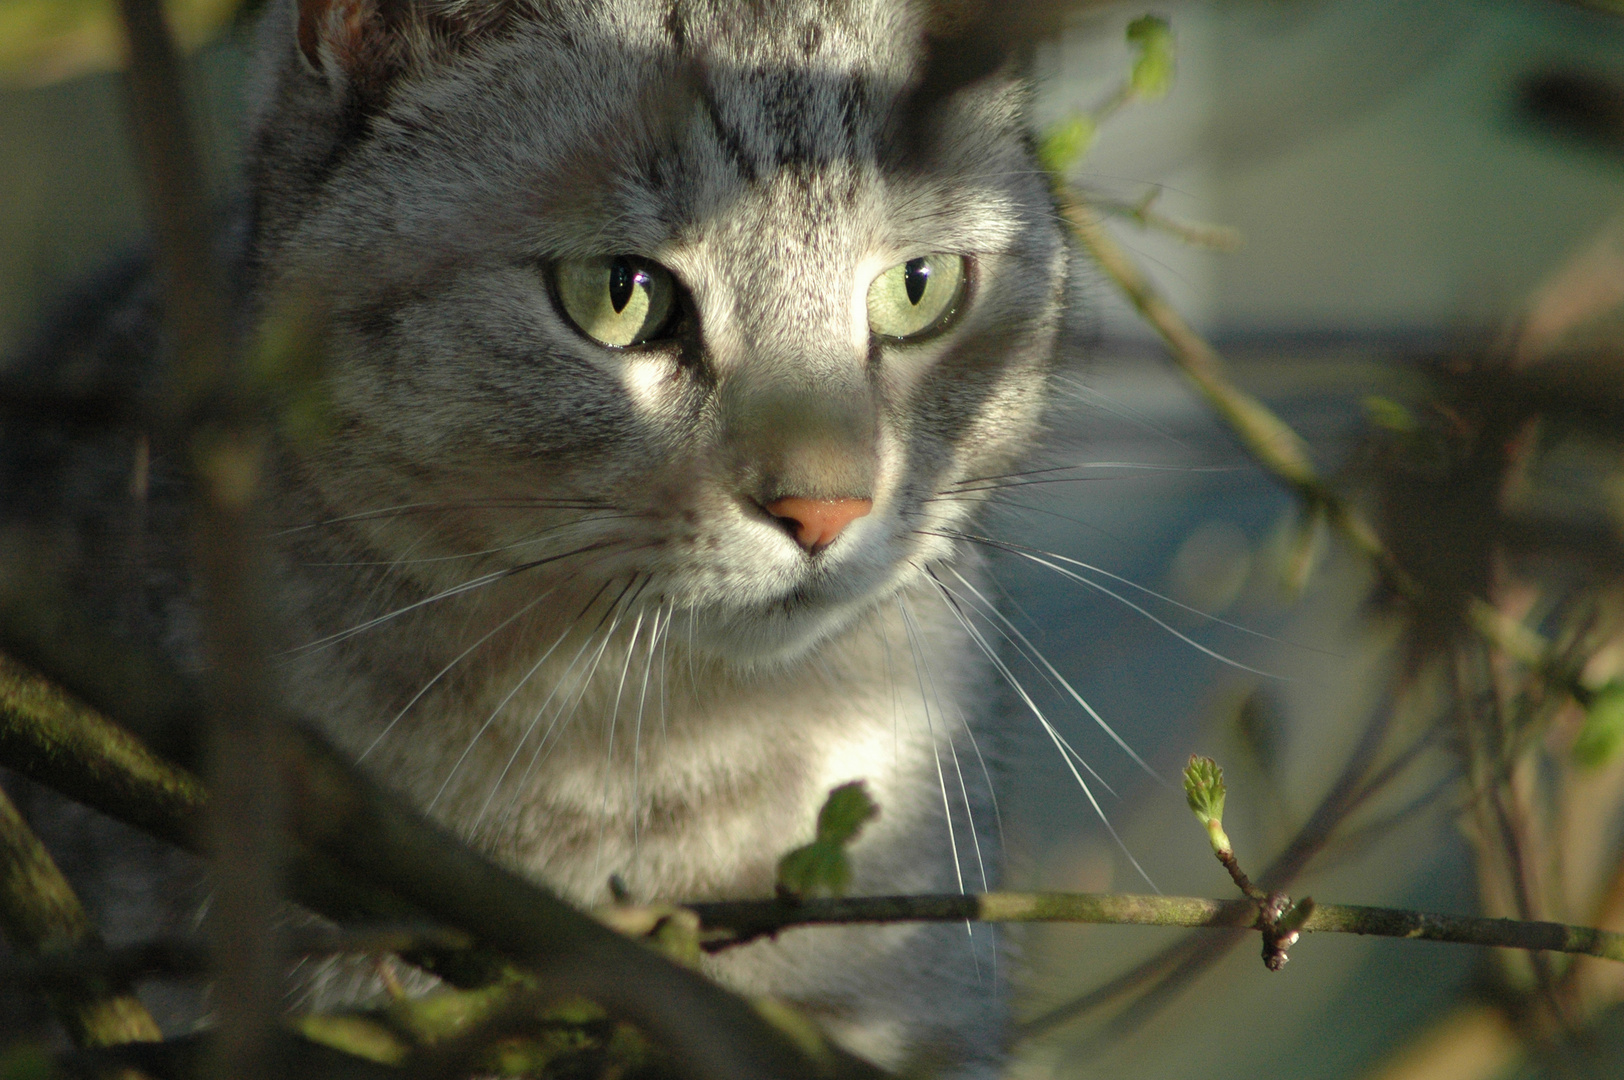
[258,0,1064,663]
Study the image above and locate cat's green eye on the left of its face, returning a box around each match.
[552,255,677,348]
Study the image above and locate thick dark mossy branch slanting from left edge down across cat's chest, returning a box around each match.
[0,613,882,1080]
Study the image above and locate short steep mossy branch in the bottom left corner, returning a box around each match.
[0,779,162,1046]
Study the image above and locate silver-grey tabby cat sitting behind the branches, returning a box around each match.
[9,0,1069,1077]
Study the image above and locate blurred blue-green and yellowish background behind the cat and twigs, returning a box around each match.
[0,0,1624,1080]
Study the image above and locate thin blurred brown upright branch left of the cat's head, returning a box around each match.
[119,0,283,1080]
